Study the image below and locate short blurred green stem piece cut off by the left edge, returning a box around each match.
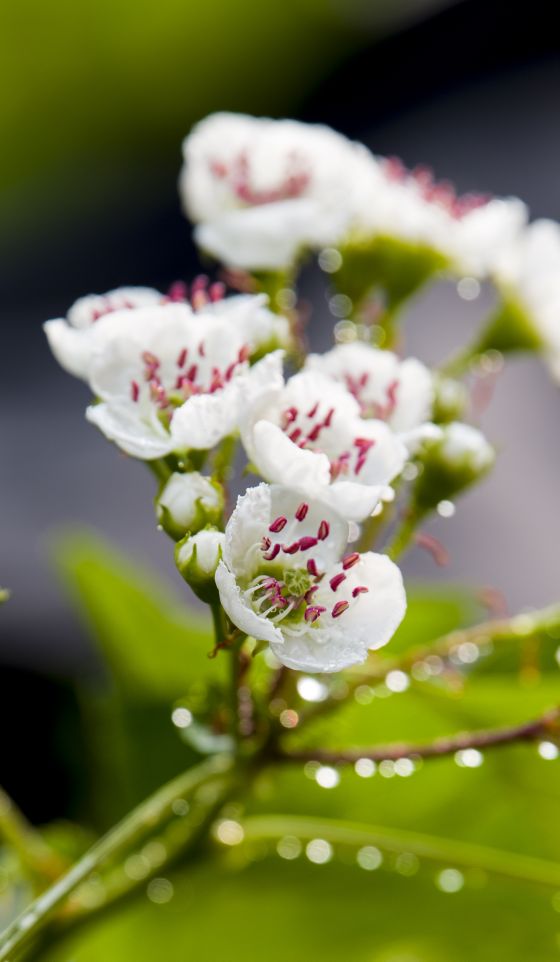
[0,788,66,882]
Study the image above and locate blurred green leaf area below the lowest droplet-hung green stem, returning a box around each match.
[41,844,558,962]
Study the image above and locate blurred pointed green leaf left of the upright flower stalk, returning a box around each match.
[54,531,219,828]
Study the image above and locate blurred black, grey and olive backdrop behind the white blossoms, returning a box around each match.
[0,0,560,818]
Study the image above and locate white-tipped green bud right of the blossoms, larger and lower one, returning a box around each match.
[413,421,495,514]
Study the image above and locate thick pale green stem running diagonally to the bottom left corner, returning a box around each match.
[0,755,232,962]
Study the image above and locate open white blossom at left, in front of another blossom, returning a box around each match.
[87,303,280,460]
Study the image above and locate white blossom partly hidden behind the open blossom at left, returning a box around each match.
[44,277,290,380]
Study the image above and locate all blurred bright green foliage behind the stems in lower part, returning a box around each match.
[8,535,560,962]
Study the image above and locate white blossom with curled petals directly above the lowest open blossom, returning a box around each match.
[241,371,407,521]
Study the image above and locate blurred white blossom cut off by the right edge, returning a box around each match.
[495,219,560,379]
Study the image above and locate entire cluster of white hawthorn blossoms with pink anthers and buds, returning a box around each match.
[45,114,560,672]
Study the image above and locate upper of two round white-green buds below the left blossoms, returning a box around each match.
[156,471,224,541]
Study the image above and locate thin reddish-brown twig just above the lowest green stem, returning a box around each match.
[276,706,560,765]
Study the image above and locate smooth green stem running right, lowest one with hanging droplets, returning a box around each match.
[243,815,560,888]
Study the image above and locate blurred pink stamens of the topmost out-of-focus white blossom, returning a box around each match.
[210,151,311,207]
